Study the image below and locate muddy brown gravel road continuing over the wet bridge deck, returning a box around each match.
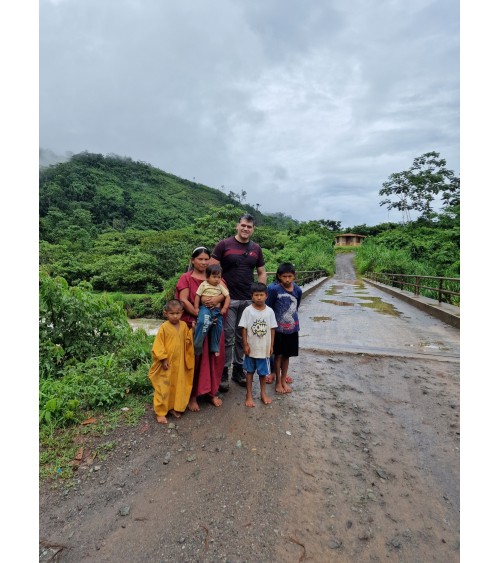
[40,261,460,563]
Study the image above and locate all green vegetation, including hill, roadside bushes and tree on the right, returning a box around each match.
[39,153,460,476]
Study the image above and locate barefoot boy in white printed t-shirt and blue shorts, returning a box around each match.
[238,283,278,407]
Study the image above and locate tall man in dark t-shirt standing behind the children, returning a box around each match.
[210,213,267,393]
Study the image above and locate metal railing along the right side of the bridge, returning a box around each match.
[364,272,460,306]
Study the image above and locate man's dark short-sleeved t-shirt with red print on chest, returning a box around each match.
[212,236,264,300]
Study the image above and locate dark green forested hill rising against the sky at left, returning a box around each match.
[39,153,274,242]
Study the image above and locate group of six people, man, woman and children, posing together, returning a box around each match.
[145,214,302,424]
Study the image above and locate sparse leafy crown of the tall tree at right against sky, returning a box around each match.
[379,152,460,223]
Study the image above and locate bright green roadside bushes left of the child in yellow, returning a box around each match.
[39,272,152,426]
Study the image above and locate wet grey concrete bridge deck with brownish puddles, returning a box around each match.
[300,275,460,360]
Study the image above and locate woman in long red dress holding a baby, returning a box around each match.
[175,246,225,412]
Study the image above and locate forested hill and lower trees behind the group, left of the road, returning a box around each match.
[39,153,340,298]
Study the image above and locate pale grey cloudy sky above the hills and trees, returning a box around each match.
[39,0,460,228]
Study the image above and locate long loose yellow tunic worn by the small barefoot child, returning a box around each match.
[149,321,194,416]
